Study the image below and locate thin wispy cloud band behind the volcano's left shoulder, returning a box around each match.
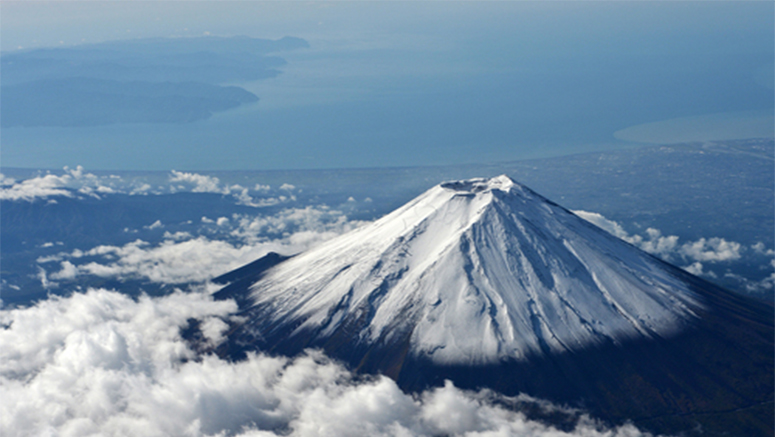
[38,207,362,289]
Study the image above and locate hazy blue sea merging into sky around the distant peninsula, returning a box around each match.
[0,1,775,170]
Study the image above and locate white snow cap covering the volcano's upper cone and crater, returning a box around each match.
[251,176,701,364]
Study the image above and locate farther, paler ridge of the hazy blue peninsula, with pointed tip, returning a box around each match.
[0,36,309,86]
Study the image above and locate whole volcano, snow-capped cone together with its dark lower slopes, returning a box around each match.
[218,176,772,434]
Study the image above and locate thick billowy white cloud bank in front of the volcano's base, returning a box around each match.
[0,290,646,437]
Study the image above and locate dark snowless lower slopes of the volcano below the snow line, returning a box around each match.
[219,254,775,437]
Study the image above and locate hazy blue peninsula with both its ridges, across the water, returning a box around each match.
[0,37,309,127]
